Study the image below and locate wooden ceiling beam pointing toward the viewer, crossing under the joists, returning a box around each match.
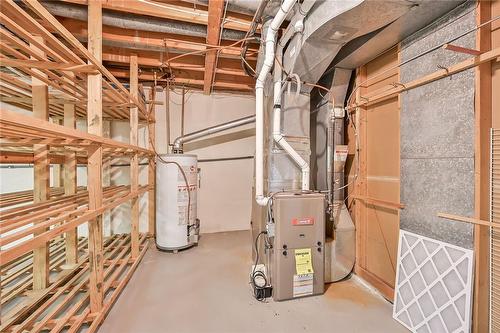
[203,0,224,95]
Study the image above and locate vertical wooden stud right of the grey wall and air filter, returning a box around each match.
[472,1,492,333]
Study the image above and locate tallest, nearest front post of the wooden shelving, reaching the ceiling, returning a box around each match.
[87,1,104,312]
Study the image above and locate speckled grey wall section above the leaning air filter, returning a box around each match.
[401,2,475,248]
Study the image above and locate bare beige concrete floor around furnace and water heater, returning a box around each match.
[99,231,407,333]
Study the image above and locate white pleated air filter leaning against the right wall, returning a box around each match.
[393,230,473,333]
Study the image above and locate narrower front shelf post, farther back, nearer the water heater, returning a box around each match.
[130,54,140,259]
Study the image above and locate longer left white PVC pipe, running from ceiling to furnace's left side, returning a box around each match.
[255,0,297,206]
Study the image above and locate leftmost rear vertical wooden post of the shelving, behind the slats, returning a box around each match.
[30,36,50,290]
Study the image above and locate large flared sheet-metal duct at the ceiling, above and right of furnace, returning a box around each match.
[283,0,412,92]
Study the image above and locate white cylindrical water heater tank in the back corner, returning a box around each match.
[156,154,199,251]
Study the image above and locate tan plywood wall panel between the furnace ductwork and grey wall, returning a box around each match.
[347,47,400,299]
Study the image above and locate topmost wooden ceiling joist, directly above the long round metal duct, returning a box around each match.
[60,0,252,31]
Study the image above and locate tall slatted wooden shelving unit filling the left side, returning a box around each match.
[0,0,155,332]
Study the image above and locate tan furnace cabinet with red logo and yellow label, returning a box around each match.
[270,193,326,301]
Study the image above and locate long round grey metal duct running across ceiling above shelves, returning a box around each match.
[42,1,246,41]
